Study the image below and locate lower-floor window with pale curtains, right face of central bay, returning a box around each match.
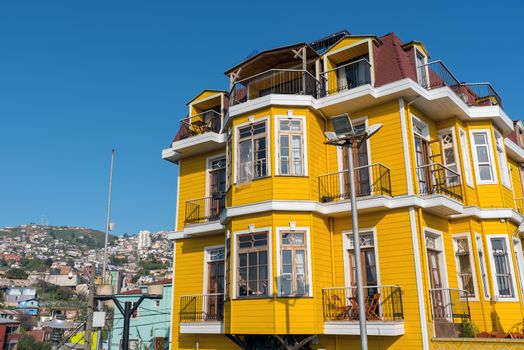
[279,231,309,296]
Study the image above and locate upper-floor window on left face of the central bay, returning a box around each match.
[238,121,267,182]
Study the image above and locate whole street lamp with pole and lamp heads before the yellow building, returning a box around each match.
[325,114,382,350]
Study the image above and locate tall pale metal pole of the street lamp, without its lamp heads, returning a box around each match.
[346,140,368,350]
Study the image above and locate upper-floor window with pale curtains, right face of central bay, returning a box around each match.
[278,118,304,176]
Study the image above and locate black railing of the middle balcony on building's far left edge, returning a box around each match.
[185,194,225,224]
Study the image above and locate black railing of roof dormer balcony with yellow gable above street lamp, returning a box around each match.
[320,59,371,95]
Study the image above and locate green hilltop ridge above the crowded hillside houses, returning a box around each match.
[0,224,116,249]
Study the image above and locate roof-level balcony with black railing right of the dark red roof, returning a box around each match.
[417,61,502,108]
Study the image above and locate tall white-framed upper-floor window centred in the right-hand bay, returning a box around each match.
[471,131,497,184]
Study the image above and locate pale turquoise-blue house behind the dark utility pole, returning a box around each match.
[109,280,173,350]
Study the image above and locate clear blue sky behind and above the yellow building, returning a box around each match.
[0,0,524,234]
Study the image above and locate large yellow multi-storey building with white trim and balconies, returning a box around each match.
[162,31,524,349]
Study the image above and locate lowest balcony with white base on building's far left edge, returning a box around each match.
[180,293,224,334]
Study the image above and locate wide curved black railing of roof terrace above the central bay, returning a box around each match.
[229,69,321,106]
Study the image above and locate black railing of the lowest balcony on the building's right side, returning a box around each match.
[429,288,470,323]
